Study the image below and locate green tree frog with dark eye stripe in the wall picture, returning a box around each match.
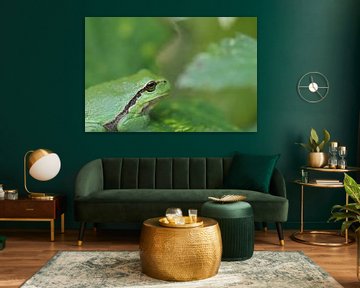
[85,70,170,132]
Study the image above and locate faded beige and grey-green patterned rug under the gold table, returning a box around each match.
[21,251,342,288]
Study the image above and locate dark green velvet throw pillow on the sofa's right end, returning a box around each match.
[224,153,280,193]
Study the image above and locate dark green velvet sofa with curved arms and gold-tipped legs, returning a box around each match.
[74,157,288,245]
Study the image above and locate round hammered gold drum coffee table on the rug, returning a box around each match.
[140,217,222,281]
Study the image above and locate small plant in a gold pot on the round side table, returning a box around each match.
[296,128,330,168]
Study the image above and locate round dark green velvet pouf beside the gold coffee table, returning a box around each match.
[201,201,255,261]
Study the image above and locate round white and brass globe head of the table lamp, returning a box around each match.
[29,149,61,181]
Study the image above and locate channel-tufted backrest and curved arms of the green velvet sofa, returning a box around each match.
[75,157,286,199]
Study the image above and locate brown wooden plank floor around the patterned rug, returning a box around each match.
[0,229,360,288]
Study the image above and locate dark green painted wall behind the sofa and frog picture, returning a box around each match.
[0,0,360,227]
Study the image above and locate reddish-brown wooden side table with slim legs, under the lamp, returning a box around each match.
[0,196,66,241]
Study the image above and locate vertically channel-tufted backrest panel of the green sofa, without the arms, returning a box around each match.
[102,157,232,189]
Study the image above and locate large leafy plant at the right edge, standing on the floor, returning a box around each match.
[329,173,360,280]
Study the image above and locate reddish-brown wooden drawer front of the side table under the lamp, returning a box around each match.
[0,200,56,218]
